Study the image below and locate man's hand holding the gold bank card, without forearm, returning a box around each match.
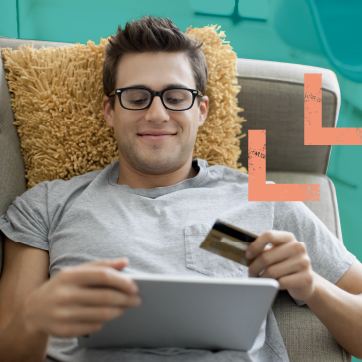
[246,230,316,301]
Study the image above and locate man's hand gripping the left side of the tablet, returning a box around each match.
[22,259,141,338]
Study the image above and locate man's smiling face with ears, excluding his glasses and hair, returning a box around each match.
[103,52,208,175]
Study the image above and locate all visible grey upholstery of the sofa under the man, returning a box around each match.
[0,38,350,362]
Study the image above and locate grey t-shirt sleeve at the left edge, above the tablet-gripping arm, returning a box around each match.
[0,182,49,250]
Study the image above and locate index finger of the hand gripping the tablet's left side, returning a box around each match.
[59,265,138,295]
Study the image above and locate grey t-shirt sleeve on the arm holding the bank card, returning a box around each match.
[273,201,356,305]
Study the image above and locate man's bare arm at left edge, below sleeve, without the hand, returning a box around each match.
[0,238,49,362]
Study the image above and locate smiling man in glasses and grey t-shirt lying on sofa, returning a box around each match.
[0,17,362,361]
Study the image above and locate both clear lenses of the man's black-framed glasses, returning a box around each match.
[121,89,193,110]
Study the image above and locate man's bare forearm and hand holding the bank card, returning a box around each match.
[247,230,362,358]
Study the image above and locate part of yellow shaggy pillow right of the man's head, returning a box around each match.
[187,25,247,173]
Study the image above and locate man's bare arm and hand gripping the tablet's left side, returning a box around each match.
[0,238,140,362]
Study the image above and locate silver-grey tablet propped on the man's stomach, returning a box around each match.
[78,274,279,351]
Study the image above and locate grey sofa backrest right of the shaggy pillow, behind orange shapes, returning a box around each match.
[237,59,341,174]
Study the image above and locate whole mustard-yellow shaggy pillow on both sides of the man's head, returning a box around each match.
[2,26,246,188]
